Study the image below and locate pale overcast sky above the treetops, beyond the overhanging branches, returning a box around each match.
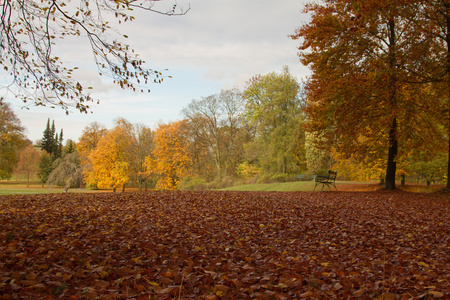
[7,0,310,142]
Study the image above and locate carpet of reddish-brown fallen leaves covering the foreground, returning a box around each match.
[0,191,450,300]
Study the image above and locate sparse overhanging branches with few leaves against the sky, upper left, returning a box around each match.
[0,0,187,112]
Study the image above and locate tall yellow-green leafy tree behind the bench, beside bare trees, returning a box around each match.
[244,67,306,174]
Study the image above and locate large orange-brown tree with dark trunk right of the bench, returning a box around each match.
[292,0,438,189]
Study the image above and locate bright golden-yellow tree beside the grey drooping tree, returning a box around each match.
[85,126,129,192]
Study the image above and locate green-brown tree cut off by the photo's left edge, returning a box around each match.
[0,99,25,179]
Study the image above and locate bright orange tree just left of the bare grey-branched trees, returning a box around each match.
[145,120,192,190]
